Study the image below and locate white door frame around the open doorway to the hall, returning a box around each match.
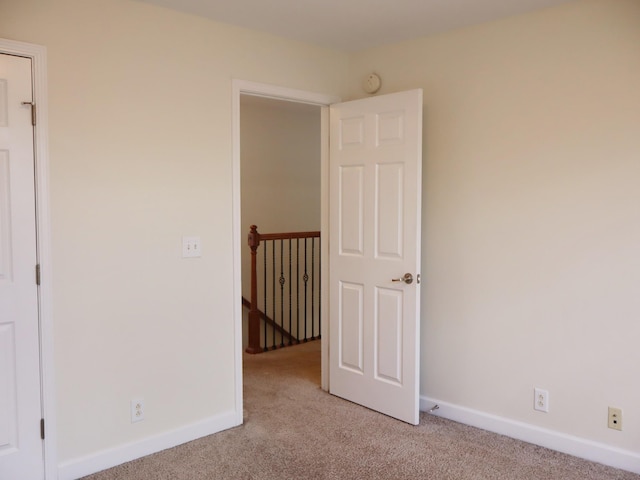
[231,80,340,412]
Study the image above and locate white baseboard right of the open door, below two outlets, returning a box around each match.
[420,396,640,473]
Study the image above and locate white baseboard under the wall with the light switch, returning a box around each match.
[58,411,239,480]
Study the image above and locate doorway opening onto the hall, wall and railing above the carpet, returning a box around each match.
[240,94,322,354]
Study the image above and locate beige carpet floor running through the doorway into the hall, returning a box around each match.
[85,341,640,480]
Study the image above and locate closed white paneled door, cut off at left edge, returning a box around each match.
[0,54,44,480]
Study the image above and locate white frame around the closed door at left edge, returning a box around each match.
[0,38,58,479]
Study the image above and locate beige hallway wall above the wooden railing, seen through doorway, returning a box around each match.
[240,96,321,238]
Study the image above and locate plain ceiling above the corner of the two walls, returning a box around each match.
[141,0,570,52]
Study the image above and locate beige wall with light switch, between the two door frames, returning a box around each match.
[0,0,347,463]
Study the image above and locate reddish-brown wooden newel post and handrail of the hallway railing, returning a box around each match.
[245,225,320,354]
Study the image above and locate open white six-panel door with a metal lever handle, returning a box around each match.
[329,90,422,425]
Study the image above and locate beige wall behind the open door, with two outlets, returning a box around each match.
[349,0,640,452]
